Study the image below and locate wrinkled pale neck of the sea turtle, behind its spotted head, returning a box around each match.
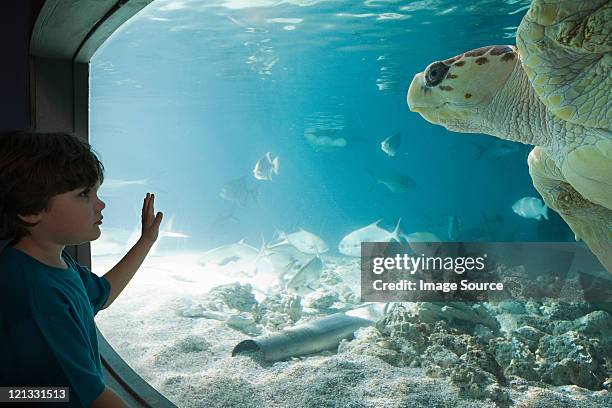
[479,56,556,146]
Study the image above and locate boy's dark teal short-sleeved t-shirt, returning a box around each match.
[0,245,110,407]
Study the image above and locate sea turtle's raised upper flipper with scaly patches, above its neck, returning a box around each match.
[516,0,612,129]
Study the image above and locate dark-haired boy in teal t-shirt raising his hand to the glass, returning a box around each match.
[0,132,162,407]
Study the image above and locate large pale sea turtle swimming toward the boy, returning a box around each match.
[407,0,612,272]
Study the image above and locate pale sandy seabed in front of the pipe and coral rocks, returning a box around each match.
[94,253,612,408]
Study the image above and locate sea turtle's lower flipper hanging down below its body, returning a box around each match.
[528,147,612,273]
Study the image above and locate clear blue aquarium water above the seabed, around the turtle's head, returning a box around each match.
[90,0,569,250]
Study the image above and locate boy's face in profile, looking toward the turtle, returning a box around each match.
[22,182,106,245]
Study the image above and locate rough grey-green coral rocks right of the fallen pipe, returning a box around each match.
[350,302,612,396]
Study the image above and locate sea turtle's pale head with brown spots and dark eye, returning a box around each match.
[408,45,518,132]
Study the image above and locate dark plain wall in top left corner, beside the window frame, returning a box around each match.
[0,0,44,131]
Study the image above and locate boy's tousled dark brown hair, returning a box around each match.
[0,131,104,243]
